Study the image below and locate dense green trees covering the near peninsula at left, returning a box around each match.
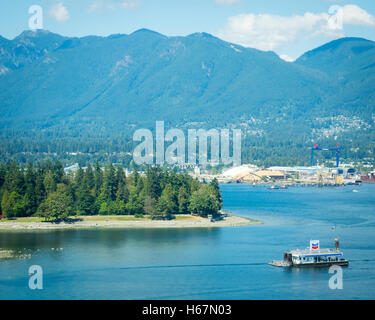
[0,160,222,220]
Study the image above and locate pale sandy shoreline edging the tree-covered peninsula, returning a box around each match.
[0,215,261,232]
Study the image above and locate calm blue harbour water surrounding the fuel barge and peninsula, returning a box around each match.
[0,185,375,299]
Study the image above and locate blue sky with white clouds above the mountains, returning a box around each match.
[0,0,375,61]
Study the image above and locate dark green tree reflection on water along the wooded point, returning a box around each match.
[0,228,221,257]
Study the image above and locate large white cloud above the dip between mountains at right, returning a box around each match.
[217,5,375,50]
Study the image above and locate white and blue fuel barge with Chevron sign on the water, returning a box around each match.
[269,238,349,268]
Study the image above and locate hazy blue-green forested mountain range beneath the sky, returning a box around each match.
[0,29,375,168]
